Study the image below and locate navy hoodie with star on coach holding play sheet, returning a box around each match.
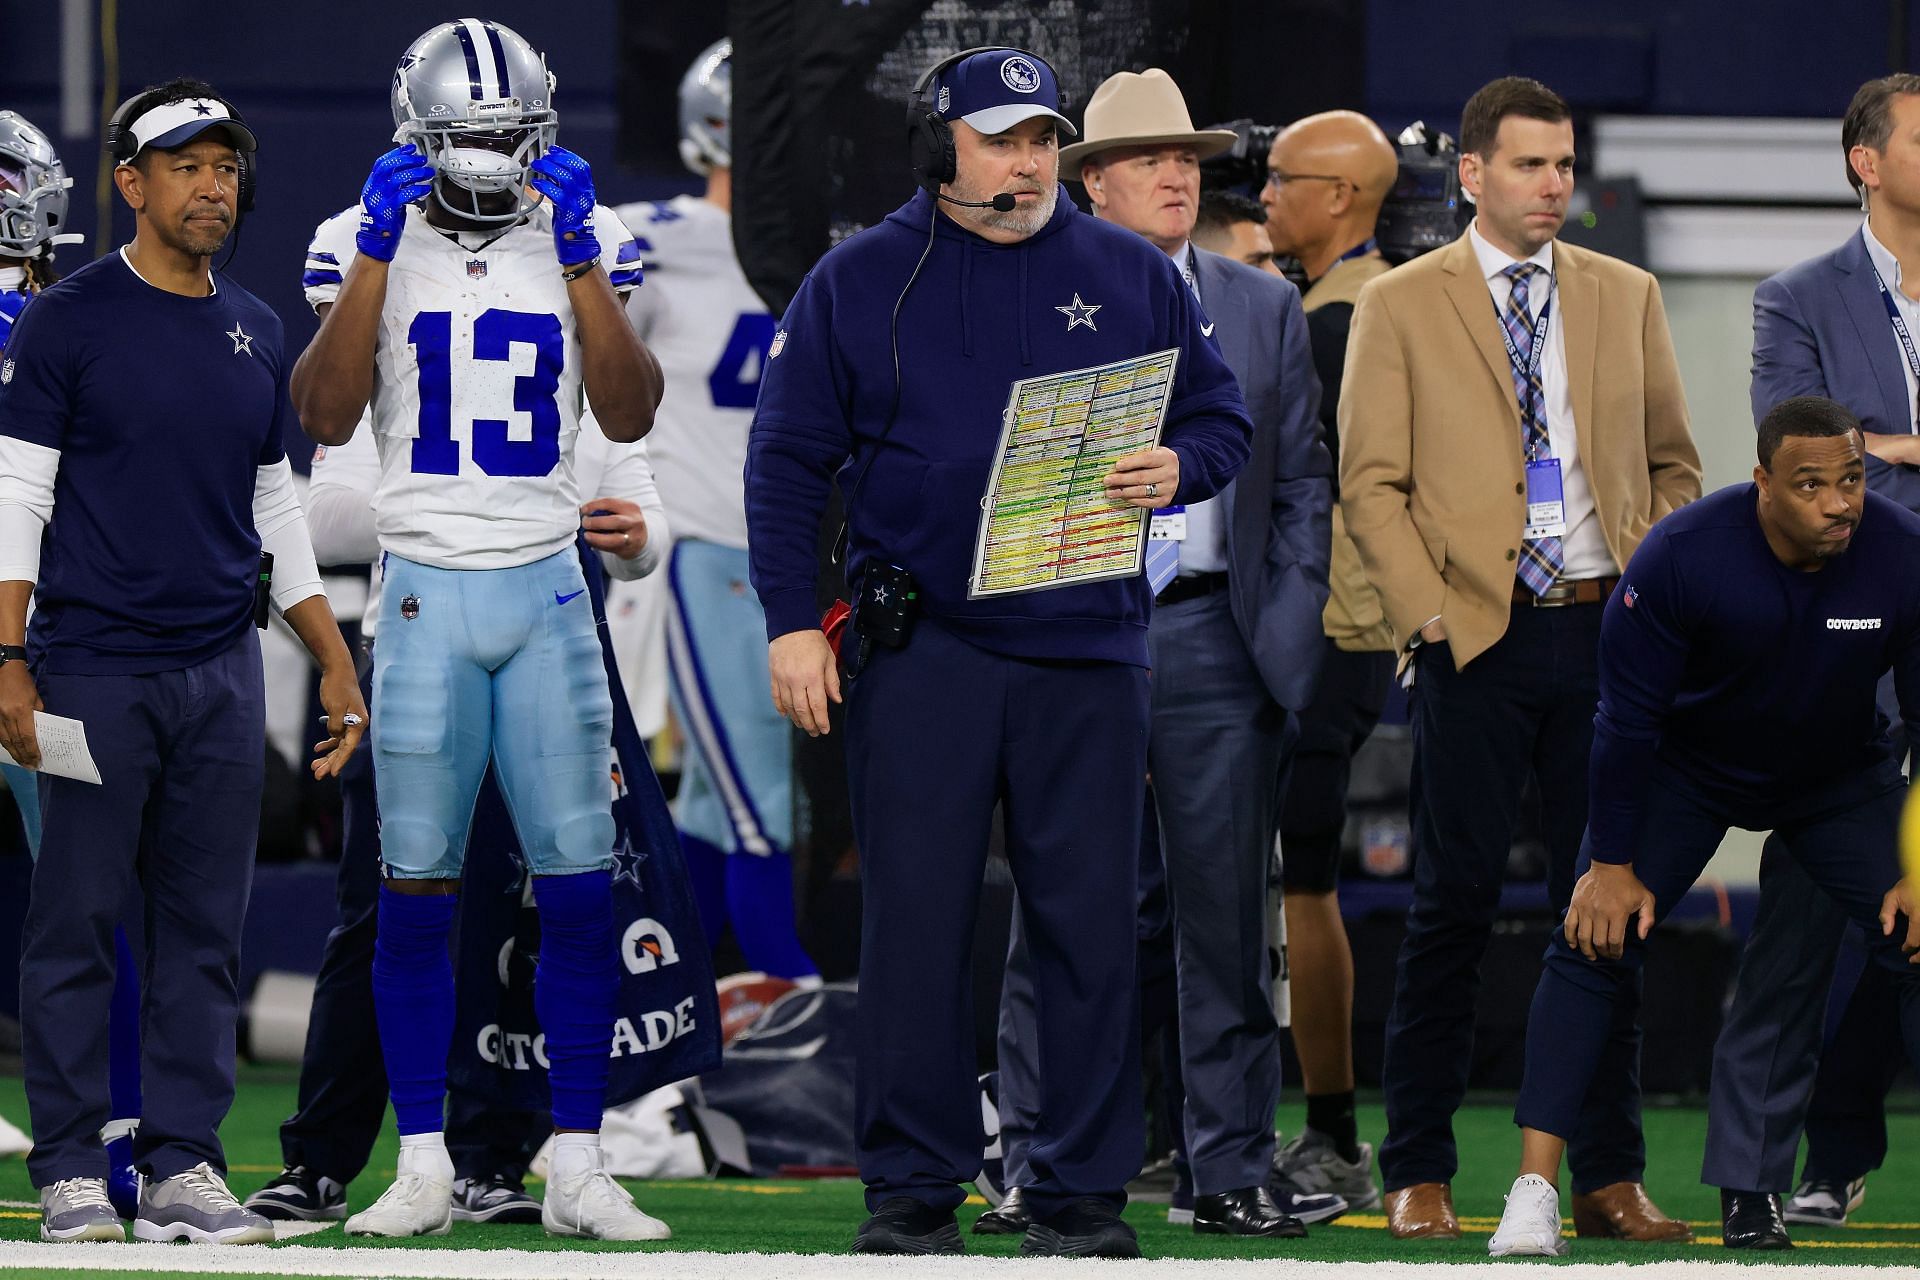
[747,190,1254,666]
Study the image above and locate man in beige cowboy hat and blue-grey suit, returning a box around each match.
[989,69,1346,1236]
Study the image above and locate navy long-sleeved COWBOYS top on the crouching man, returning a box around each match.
[1588,484,1920,864]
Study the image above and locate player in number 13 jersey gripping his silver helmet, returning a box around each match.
[292,17,668,1240]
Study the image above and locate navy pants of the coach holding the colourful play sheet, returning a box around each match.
[847,620,1146,1217]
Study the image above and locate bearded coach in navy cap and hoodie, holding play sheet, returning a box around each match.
[747,48,1252,1257]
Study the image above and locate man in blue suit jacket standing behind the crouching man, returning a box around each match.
[1701,75,1920,1244]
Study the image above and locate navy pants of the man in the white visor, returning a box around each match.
[19,628,267,1186]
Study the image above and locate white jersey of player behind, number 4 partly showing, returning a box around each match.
[618,196,776,547]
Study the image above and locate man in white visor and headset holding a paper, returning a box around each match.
[0,81,367,1244]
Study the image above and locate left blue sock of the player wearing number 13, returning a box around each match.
[372,885,461,1138]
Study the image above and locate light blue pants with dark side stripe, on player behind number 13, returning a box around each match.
[666,539,793,856]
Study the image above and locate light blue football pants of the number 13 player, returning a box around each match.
[372,547,614,879]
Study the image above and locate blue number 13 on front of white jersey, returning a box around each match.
[407,309,566,476]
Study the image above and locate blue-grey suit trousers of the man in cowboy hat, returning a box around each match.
[1000,593,1294,1196]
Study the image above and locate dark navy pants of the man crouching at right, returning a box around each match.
[1513,762,1920,1159]
